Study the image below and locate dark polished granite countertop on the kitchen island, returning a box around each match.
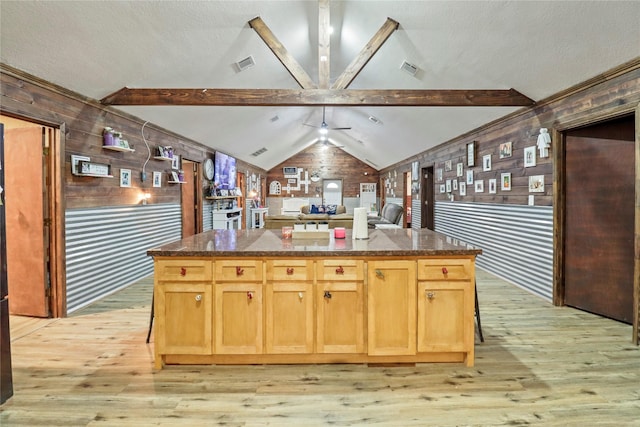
[147,228,482,257]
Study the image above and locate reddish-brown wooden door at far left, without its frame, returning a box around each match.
[4,126,49,317]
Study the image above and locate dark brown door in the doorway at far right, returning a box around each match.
[564,117,635,323]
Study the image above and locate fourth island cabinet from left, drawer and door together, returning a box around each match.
[316,259,365,354]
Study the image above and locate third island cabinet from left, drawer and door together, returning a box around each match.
[265,260,315,354]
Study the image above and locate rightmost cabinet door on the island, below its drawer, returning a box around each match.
[418,282,473,352]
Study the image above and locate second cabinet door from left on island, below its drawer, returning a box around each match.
[215,283,263,354]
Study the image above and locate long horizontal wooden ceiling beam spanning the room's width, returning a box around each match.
[101,87,535,107]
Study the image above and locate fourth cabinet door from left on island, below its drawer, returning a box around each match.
[316,282,364,353]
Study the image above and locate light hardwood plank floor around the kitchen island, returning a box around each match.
[0,271,640,427]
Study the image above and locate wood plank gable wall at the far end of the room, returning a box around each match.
[267,142,378,198]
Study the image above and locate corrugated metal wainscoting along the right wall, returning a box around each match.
[435,202,553,301]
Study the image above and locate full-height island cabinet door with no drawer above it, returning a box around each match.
[367,261,417,356]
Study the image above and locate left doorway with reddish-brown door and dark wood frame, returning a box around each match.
[0,116,66,317]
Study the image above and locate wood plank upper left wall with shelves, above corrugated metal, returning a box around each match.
[0,65,266,209]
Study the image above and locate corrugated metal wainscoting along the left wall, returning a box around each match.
[65,204,182,313]
